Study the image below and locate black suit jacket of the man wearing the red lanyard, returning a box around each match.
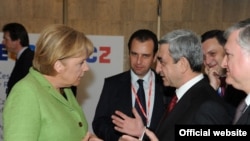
[92,71,172,141]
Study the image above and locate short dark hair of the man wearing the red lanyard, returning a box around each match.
[128,29,158,55]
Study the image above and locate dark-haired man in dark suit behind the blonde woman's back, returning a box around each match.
[2,23,34,98]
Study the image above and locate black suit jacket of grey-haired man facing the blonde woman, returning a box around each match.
[156,79,232,141]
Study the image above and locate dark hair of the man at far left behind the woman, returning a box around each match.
[2,23,29,47]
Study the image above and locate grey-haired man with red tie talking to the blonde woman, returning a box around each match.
[114,30,231,141]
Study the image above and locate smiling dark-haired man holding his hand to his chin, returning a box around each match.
[201,29,246,114]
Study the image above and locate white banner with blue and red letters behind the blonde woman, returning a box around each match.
[0,32,124,141]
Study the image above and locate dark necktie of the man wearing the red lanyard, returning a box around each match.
[135,79,147,125]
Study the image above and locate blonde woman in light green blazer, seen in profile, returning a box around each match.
[3,24,100,141]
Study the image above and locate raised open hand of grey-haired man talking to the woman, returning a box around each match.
[111,108,145,137]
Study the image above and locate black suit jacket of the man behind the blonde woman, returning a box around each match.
[6,48,34,96]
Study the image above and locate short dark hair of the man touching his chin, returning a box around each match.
[201,29,227,46]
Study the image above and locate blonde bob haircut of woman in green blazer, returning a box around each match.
[33,24,94,76]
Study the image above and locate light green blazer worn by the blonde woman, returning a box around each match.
[3,68,88,141]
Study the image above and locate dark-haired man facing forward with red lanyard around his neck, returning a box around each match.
[92,29,174,141]
